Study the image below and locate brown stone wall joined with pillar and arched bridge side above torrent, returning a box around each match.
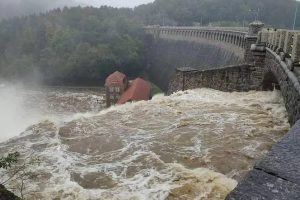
[168,48,300,125]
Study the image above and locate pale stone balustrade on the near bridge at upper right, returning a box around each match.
[257,29,300,70]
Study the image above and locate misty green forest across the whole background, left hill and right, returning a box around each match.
[0,0,300,84]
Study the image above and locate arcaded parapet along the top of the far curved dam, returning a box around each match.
[145,26,248,48]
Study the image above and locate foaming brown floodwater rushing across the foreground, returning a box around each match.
[0,85,289,200]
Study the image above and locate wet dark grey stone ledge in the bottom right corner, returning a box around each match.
[226,120,300,200]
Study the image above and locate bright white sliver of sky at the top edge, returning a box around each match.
[75,0,154,8]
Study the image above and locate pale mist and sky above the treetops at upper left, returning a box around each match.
[0,0,154,19]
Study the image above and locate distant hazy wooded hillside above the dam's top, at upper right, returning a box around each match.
[136,0,300,28]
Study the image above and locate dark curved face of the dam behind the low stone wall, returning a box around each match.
[145,27,244,91]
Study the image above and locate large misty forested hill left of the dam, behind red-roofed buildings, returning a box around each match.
[0,7,143,84]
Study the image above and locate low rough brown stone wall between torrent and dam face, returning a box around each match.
[168,64,264,93]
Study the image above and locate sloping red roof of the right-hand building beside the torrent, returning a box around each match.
[118,78,151,104]
